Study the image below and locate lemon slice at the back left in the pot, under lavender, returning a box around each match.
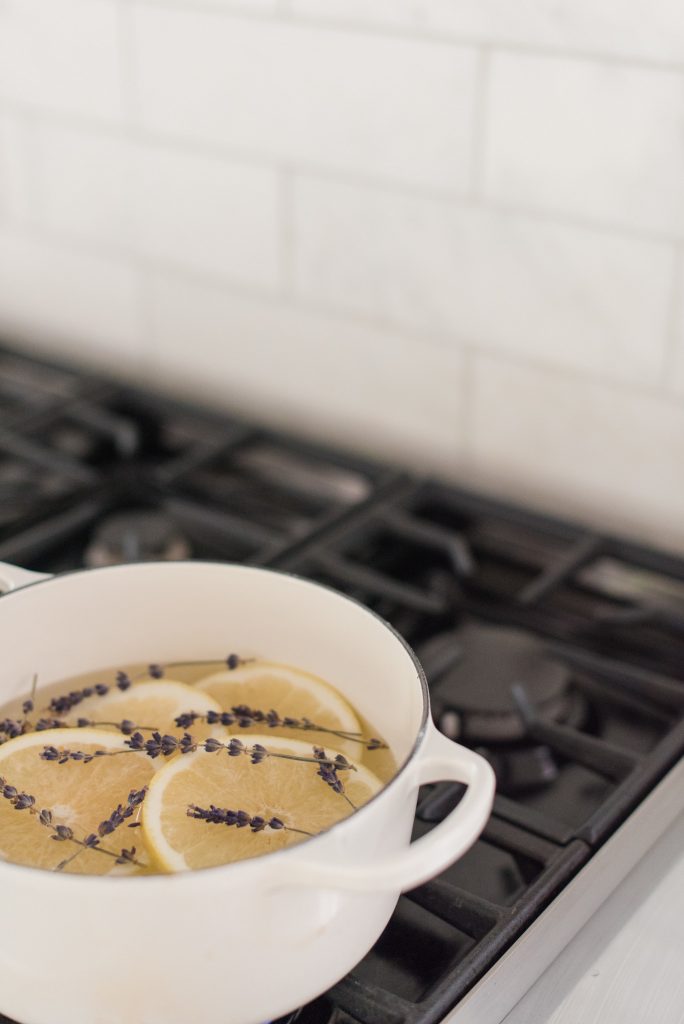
[60,679,225,739]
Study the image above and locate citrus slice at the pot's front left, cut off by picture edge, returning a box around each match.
[0,729,158,874]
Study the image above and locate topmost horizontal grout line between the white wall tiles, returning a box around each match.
[125,0,684,73]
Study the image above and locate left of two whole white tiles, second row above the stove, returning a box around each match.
[34,128,279,287]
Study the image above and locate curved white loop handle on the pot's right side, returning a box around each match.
[282,724,496,892]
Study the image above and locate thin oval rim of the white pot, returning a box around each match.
[0,558,430,888]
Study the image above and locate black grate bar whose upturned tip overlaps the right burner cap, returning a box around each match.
[513,686,641,782]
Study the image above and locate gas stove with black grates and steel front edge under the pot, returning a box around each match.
[0,349,684,1024]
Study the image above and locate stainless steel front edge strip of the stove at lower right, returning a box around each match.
[442,761,684,1024]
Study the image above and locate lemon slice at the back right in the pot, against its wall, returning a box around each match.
[195,660,364,757]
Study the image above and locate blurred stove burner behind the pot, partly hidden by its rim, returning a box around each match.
[84,509,193,568]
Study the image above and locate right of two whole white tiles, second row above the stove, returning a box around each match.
[295,178,674,383]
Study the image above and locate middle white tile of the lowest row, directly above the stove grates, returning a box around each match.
[148,278,462,466]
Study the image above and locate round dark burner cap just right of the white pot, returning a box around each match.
[420,623,573,742]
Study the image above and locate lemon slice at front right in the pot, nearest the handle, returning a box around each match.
[142,732,382,871]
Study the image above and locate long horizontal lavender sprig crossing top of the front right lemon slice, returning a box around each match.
[40,731,356,771]
